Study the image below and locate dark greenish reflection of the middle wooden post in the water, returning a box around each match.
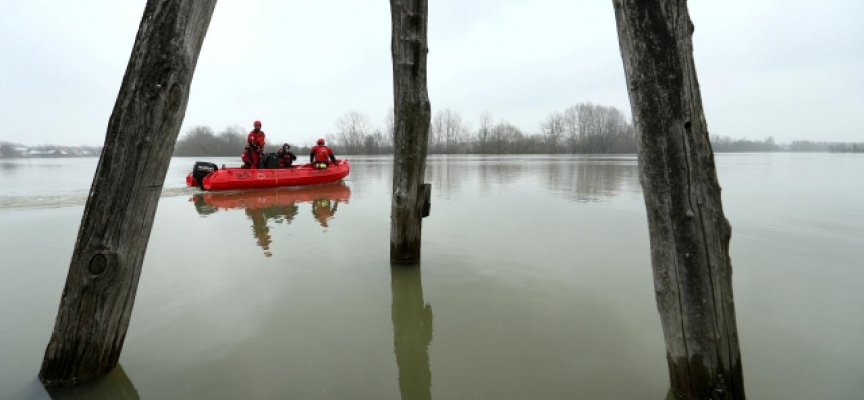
[390,266,432,400]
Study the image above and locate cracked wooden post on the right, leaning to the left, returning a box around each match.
[613,0,744,400]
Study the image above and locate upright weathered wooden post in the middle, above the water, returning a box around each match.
[390,0,431,263]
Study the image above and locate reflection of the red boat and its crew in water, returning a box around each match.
[190,182,351,257]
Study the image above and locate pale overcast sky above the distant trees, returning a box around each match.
[0,0,864,145]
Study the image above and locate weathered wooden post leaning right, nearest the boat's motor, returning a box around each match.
[39,0,216,385]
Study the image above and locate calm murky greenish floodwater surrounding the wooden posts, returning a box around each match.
[0,154,864,400]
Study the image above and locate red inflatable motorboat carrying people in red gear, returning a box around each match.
[186,160,351,190]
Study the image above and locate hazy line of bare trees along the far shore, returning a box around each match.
[167,103,861,157]
